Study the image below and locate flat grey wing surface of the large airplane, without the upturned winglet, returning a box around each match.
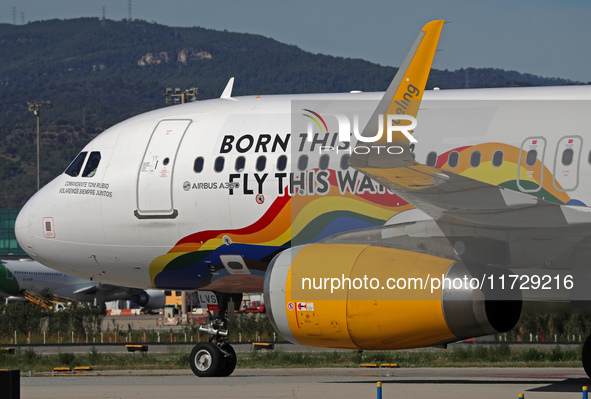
[351,152,591,229]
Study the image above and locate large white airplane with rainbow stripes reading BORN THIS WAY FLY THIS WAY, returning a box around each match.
[15,21,591,377]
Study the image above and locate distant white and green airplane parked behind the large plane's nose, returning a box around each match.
[0,259,166,309]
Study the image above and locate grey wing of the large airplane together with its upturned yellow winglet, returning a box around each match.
[346,21,591,284]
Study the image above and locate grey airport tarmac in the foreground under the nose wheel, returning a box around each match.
[21,368,591,399]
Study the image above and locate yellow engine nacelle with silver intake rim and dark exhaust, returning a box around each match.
[264,244,521,350]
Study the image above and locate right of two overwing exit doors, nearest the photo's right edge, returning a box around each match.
[554,136,583,191]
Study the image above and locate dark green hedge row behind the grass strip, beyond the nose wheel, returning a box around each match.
[0,302,591,345]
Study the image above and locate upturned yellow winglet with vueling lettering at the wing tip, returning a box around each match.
[351,20,444,158]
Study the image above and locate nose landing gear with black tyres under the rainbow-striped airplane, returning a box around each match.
[189,295,242,377]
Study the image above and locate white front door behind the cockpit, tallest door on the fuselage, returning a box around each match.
[135,119,191,219]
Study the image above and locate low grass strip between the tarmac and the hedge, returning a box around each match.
[0,345,581,372]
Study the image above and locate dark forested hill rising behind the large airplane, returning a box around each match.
[0,18,574,209]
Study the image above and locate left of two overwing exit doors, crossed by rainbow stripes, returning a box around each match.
[517,137,546,193]
